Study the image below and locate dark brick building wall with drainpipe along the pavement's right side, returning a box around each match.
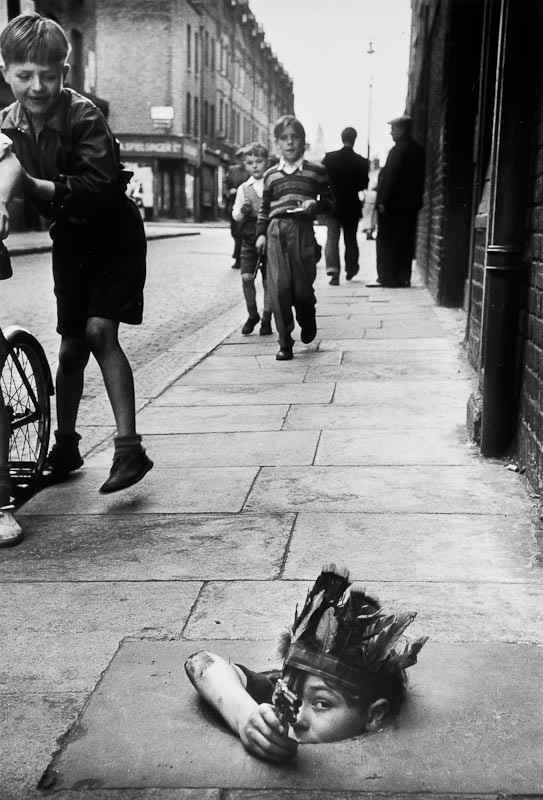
[407,0,543,489]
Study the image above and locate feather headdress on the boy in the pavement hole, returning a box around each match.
[279,564,428,696]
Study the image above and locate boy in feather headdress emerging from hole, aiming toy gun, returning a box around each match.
[185,564,427,761]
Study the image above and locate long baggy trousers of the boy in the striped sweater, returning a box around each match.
[266,217,317,348]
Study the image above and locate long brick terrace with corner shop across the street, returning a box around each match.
[0,0,294,219]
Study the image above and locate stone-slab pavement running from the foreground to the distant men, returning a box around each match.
[0,234,543,800]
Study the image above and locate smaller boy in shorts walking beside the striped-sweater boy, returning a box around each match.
[232,142,273,336]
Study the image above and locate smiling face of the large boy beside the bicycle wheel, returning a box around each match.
[2,61,69,117]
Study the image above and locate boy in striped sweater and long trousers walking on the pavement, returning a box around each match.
[256,114,332,361]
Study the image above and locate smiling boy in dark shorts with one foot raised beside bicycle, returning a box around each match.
[0,13,153,493]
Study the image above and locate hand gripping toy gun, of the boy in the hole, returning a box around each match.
[239,703,298,761]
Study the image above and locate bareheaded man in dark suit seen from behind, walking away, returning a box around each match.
[322,128,369,286]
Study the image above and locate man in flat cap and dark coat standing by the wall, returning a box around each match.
[376,116,425,287]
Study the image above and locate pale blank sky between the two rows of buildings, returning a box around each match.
[249,0,411,158]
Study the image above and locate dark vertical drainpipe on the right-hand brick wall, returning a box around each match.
[481,0,530,456]
